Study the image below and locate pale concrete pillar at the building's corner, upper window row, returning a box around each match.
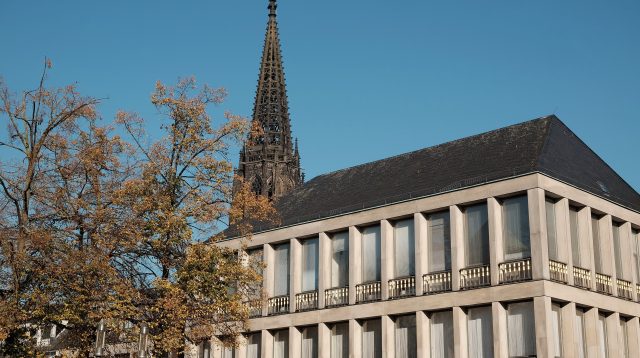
[527,188,550,280]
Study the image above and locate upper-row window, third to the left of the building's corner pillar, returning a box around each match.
[427,211,451,272]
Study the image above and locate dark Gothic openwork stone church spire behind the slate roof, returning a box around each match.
[237,0,304,199]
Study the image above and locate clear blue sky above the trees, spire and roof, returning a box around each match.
[0,0,640,190]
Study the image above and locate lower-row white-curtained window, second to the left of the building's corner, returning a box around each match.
[467,307,493,358]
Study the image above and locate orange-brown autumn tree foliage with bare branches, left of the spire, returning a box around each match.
[0,62,276,356]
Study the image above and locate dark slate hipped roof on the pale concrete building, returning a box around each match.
[245,116,640,235]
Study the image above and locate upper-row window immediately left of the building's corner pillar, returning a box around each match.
[502,196,531,260]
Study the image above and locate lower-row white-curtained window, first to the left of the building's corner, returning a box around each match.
[507,302,536,357]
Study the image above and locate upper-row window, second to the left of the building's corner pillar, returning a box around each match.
[464,203,489,266]
